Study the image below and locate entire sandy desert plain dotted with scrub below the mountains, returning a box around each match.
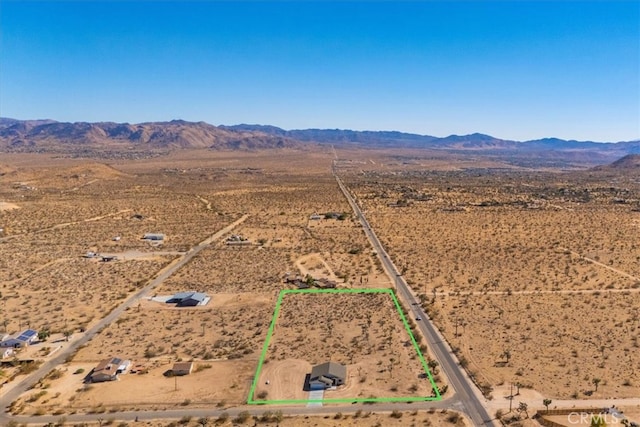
[0,145,640,426]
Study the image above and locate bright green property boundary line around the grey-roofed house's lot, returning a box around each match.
[247,289,442,405]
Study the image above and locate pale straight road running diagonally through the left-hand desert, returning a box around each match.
[0,215,248,424]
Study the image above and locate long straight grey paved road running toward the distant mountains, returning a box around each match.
[334,170,494,426]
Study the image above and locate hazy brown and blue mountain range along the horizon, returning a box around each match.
[0,118,640,164]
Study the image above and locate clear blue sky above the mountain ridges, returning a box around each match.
[0,0,640,141]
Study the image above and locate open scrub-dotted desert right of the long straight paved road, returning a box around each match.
[343,158,640,398]
